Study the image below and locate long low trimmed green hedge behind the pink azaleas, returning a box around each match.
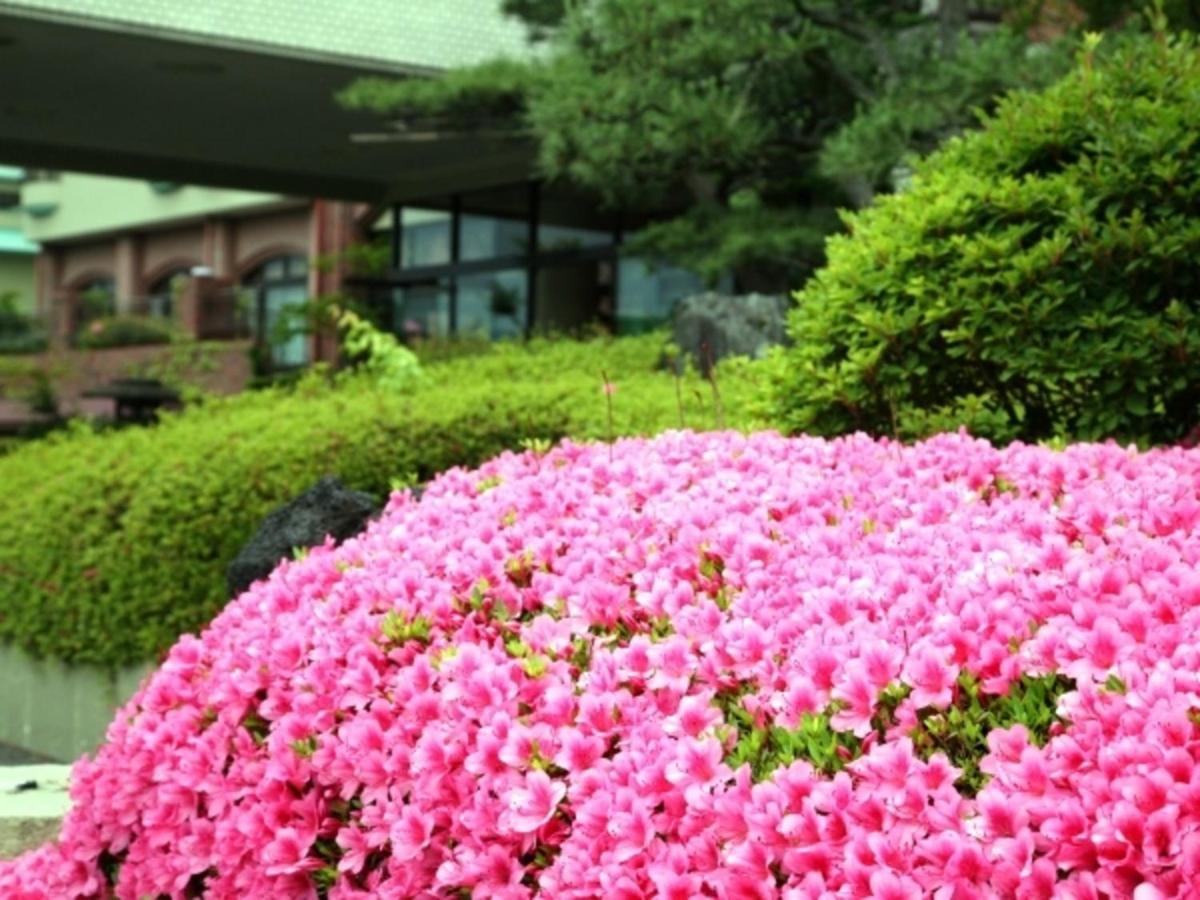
[0,335,757,665]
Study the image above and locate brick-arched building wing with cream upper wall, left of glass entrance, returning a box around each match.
[20,173,360,367]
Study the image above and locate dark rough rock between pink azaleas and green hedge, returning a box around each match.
[226,475,378,596]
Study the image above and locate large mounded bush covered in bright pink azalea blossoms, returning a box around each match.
[0,432,1200,900]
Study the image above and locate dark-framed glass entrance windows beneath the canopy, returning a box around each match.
[376,184,703,340]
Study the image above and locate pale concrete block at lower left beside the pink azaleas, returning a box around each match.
[0,755,71,859]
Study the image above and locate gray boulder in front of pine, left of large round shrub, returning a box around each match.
[673,292,788,374]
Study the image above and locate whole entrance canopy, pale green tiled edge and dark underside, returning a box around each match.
[0,0,530,200]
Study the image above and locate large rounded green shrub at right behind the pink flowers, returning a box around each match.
[773,36,1200,443]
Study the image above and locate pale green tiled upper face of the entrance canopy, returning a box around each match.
[0,0,530,68]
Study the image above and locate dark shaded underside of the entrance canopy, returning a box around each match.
[0,2,533,203]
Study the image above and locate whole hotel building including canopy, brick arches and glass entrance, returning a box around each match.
[0,0,698,367]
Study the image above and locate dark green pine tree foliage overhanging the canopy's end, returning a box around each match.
[342,0,1186,289]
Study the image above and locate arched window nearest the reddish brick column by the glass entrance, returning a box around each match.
[241,254,308,368]
